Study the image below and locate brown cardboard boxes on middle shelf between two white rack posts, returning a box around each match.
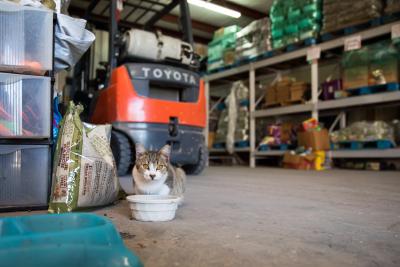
[265,77,311,107]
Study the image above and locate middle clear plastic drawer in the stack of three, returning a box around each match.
[0,73,51,139]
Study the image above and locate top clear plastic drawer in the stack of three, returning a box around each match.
[0,2,53,75]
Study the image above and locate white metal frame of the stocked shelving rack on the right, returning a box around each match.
[204,21,400,168]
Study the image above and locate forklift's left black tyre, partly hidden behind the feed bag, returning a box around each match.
[111,131,133,176]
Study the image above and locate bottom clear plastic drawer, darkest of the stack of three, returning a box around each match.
[0,145,51,209]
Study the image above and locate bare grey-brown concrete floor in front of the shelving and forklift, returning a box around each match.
[3,167,400,267]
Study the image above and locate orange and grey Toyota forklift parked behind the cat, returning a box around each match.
[86,0,208,175]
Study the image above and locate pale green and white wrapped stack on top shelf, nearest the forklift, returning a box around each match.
[207,25,240,72]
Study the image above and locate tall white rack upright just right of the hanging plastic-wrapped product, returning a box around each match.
[249,63,256,168]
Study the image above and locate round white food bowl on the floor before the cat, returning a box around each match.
[126,195,180,222]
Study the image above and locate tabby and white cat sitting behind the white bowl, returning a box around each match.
[132,143,186,200]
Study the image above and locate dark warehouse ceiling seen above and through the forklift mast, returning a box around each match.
[69,0,273,43]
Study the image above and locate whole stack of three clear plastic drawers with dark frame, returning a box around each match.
[0,2,53,209]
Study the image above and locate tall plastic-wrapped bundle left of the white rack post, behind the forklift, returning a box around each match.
[214,81,249,153]
